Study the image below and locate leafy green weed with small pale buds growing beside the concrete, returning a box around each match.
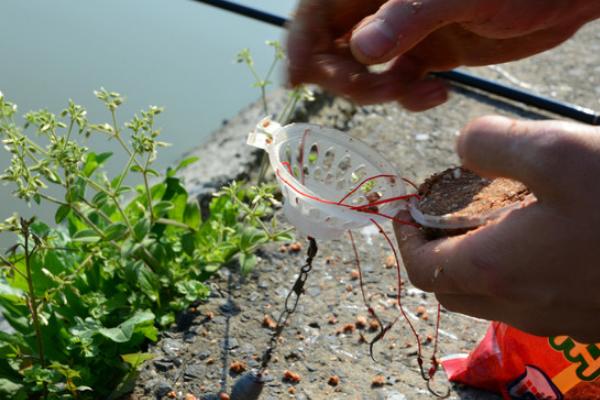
[0,89,290,399]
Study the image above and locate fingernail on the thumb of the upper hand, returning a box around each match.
[352,19,396,58]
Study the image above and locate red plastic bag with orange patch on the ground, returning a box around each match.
[442,322,600,400]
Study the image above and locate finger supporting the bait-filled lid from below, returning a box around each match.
[394,204,545,298]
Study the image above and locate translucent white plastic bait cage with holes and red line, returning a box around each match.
[248,118,407,239]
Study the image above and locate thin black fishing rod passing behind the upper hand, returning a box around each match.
[194,0,600,125]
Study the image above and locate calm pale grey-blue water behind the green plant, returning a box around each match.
[0,0,295,238]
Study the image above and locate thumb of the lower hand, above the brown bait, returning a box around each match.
[457,116,597,200]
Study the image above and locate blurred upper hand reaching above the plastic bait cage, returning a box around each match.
[288,0,600,111]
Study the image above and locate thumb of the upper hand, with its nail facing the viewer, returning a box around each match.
[350,0,495,64]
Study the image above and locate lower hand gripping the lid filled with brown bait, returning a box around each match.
[395,117,600,343]
